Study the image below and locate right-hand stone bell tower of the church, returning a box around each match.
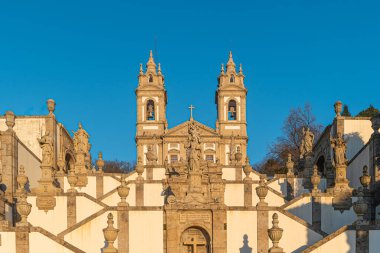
[215,52,248,165]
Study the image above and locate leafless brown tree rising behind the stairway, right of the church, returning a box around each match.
[254,104,323,175]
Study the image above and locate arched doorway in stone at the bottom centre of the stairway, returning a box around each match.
[180,227,211,253]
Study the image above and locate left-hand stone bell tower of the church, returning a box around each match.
[135,51,168,165]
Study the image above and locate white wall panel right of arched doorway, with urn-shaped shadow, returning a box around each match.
[227,211,257,253]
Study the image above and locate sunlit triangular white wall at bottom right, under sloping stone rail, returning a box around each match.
[311,230,356,253]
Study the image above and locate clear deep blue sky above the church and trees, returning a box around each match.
[0,0,380,162]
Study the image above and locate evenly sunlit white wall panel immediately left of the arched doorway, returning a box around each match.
[129,211,164,253]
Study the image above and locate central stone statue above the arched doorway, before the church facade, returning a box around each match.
[186,122,201,171]
